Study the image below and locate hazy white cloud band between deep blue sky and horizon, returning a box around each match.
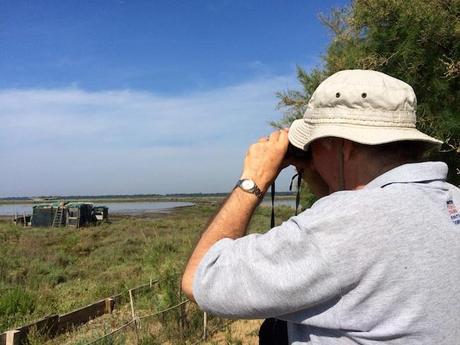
[0,77,296,196]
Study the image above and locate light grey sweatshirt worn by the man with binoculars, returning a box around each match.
[193,162,460,345]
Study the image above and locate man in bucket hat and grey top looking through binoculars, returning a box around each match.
[182,70,460,345]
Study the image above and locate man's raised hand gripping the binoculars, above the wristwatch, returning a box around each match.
[241,129,289,193]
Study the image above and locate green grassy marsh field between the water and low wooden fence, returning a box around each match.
[0,200,293,344]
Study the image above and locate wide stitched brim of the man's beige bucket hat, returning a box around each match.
[289,119,442,150]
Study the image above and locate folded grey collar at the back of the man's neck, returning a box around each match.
[364,162,448,189]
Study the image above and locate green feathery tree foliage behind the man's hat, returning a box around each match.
[272,0,460,184]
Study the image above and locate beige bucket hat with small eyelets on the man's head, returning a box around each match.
[289,70,442,150]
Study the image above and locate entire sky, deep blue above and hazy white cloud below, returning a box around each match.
[0,0,347,197]
